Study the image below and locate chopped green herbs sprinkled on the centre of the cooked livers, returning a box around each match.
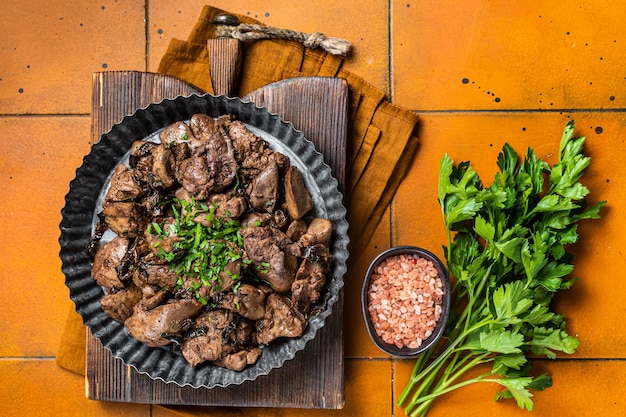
[146,198,250,304]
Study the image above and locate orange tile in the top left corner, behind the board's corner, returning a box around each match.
[0,0,146,114]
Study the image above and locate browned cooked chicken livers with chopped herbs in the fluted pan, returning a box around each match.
[92,114,334,371]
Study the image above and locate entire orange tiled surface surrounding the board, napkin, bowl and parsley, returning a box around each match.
[0,0,626,417]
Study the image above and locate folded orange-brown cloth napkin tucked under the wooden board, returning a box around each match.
[57,6,418,386]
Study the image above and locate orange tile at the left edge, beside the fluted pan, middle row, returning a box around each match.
[0,116,91,357]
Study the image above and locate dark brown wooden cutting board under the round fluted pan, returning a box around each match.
[85,71,348,409]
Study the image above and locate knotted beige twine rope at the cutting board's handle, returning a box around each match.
[216,23,350,57]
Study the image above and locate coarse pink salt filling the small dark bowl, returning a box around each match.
[367,254,443,349]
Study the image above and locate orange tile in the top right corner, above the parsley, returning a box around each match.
[392,0,626,110]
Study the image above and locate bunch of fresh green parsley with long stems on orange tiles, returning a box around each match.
[398,121,606,416]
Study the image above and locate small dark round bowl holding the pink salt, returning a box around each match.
[361,246,450,358]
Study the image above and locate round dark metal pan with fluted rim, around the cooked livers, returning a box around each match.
[59,94,349,388]
